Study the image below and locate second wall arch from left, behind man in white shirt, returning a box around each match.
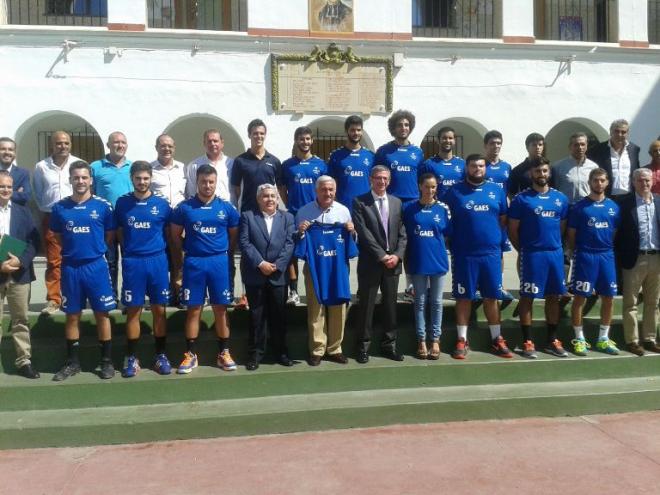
[163,113,246,163]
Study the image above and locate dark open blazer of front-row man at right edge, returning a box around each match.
[614,193,660,270]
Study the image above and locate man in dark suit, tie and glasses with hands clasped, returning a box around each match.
[353,165,406,364]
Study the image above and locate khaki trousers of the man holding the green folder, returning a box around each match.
[0,281,32,368]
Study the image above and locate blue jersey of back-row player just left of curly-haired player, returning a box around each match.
[328,147,375,210]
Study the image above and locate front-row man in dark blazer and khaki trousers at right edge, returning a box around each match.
[614,168,660,356]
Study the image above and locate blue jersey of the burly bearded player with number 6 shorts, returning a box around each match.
[445,181,507,256]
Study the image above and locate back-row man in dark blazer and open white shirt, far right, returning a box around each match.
[587,119,639,201]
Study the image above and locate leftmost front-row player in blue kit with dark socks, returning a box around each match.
[49,160,117,382]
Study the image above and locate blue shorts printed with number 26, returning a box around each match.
[520,248,566,299]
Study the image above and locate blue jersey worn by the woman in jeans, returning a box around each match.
[403,201,451,275]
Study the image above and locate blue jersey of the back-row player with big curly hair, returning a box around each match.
[374,141,424,202]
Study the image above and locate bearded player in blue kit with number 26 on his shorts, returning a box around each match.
[508,157,568,359]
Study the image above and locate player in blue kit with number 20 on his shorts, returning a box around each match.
[567,168,620,356]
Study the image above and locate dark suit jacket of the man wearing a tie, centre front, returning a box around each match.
[353,191,407,279]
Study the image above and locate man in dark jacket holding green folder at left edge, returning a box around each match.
[0,170,39,378]
